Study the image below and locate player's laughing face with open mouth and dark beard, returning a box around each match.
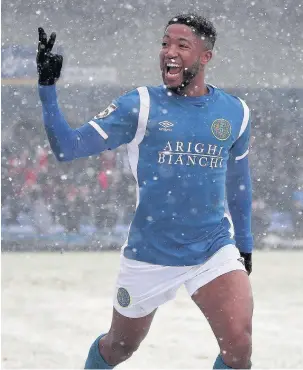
[160,24,211,89]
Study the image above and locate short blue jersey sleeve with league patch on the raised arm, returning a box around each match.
[88,90,140,149]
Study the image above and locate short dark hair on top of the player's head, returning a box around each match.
[165,13,217,50]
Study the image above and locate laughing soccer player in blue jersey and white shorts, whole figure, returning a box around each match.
[37,14,253,369]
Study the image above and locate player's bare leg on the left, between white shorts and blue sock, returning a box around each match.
[99,308,156,365]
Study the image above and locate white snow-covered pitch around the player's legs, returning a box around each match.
[1,251,303,369]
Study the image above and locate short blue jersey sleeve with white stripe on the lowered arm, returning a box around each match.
[230,99,251,161]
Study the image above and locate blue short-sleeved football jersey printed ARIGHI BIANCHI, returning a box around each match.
[89,85,250,266]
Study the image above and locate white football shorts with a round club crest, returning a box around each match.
[114,244,245,318]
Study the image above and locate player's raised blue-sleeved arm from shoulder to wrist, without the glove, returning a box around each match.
[39,85,139,161]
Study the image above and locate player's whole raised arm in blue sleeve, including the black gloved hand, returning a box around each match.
[37,28,139,161]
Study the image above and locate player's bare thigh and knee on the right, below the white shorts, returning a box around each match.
[192,270,253,368]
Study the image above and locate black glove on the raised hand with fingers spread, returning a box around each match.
[36,27,63,85]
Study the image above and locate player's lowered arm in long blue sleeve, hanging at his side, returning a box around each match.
[226,108,253,273]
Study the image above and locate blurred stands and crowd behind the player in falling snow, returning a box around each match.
[1,0,303,250]
